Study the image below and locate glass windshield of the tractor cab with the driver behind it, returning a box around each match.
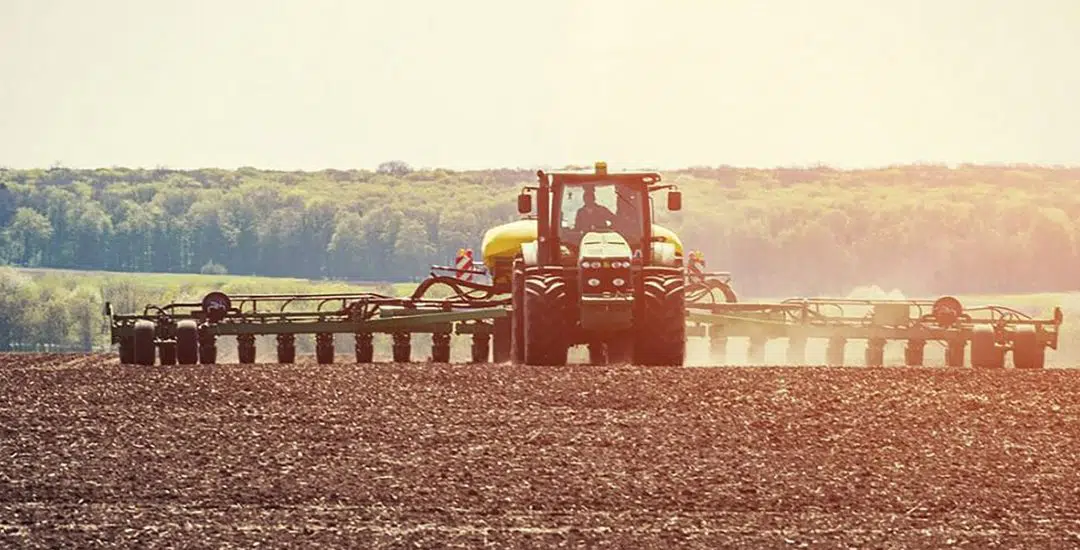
[558,182,646,249]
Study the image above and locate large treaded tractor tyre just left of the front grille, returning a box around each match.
[524,273,570,366]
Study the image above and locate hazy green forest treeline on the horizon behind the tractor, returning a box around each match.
[0,163,1080,296]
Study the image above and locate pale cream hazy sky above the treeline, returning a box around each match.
[0,0,1080,170]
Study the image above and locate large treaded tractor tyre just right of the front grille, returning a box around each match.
[634,269,686,366]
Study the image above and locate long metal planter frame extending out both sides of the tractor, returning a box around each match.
[108,272,1063,358]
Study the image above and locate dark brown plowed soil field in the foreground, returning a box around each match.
[0,356,1080,548]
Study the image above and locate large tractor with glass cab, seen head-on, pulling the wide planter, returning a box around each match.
[483,162,687,365]
